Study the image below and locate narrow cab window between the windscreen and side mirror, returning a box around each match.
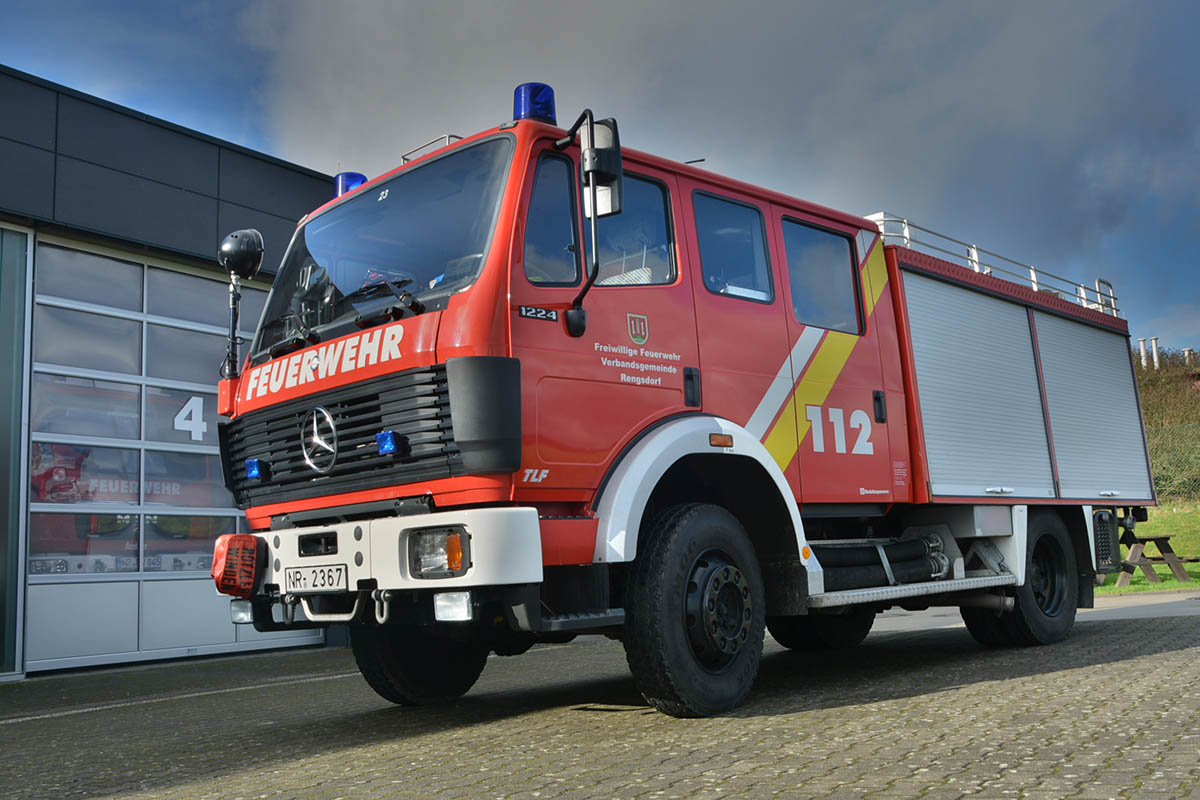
[524,155,580,285]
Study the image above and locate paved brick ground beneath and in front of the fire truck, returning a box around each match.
[0,593,1200,800]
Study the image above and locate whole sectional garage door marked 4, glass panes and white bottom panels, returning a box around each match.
[25,239,319,670]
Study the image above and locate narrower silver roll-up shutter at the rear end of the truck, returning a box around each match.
[1034,312,1151,501]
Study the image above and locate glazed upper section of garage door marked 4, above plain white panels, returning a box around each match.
[28,242,266,581]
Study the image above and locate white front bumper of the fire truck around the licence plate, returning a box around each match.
[265,509,541,591]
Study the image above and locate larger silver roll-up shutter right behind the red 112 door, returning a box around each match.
[904,272,1055,498]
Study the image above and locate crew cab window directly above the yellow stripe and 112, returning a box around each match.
[784,219,863,333]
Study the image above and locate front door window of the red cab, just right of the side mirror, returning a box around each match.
[583,173,676,287]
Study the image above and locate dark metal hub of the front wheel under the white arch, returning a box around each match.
[684,552,754,672]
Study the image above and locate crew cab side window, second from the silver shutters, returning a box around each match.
[692,192,775,302]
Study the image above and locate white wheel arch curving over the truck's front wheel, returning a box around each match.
[593,415,824,594]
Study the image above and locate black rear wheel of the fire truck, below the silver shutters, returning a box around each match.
[1001,511,1079,645]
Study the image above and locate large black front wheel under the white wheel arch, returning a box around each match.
[624,503,767,717]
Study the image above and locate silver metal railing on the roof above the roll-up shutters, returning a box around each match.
[866,211,1122,317]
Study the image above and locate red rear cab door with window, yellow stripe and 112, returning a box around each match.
[772,206,902,505]
